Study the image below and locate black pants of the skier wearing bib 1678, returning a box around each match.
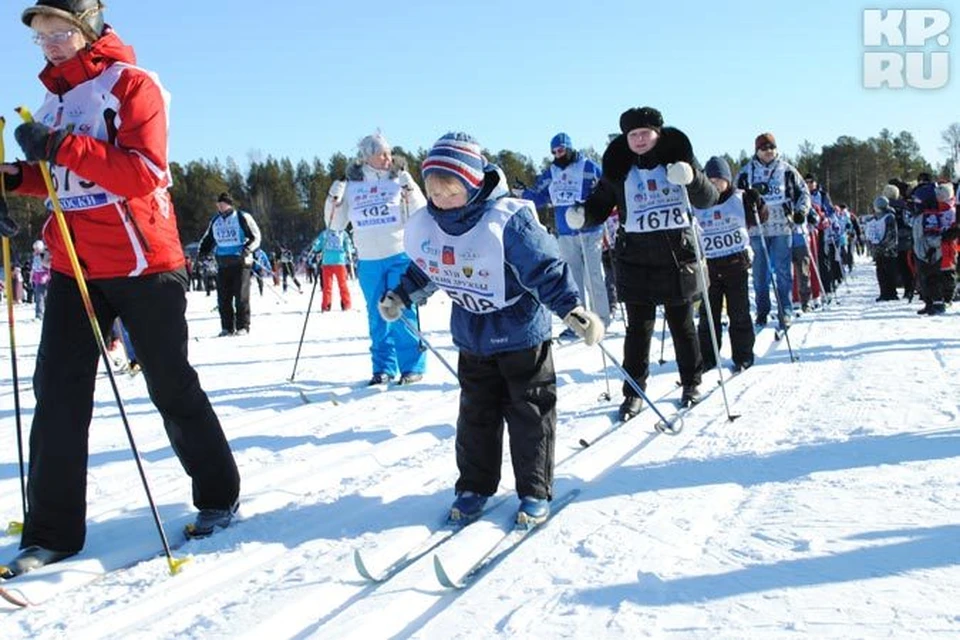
[623,302,703,397]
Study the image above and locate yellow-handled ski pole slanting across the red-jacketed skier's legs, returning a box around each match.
[17,107,190,575]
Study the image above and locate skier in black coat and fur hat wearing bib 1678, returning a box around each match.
[567,107,718,420]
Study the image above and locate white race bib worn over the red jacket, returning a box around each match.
[35,62,170,211]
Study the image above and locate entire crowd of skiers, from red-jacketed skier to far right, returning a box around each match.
[0,0,957,577]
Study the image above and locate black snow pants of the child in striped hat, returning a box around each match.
[456,341,557,499]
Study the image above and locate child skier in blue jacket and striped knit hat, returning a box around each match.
[379,133,604,527]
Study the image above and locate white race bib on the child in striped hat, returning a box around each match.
[405,198,529,314]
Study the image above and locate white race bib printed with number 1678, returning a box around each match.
[624,165,690,233]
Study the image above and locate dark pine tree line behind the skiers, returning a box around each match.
[1,123,960,255]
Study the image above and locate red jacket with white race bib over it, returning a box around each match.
[17,27,184,279]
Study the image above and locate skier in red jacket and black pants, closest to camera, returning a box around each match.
[0,0,240,577]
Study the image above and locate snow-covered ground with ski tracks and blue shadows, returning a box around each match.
[0,264,960,639]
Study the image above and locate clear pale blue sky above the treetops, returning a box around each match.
[0,0,960,172]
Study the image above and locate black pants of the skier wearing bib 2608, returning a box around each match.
[698,266,752,369]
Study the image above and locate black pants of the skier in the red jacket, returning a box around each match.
[20,269,240,551]
